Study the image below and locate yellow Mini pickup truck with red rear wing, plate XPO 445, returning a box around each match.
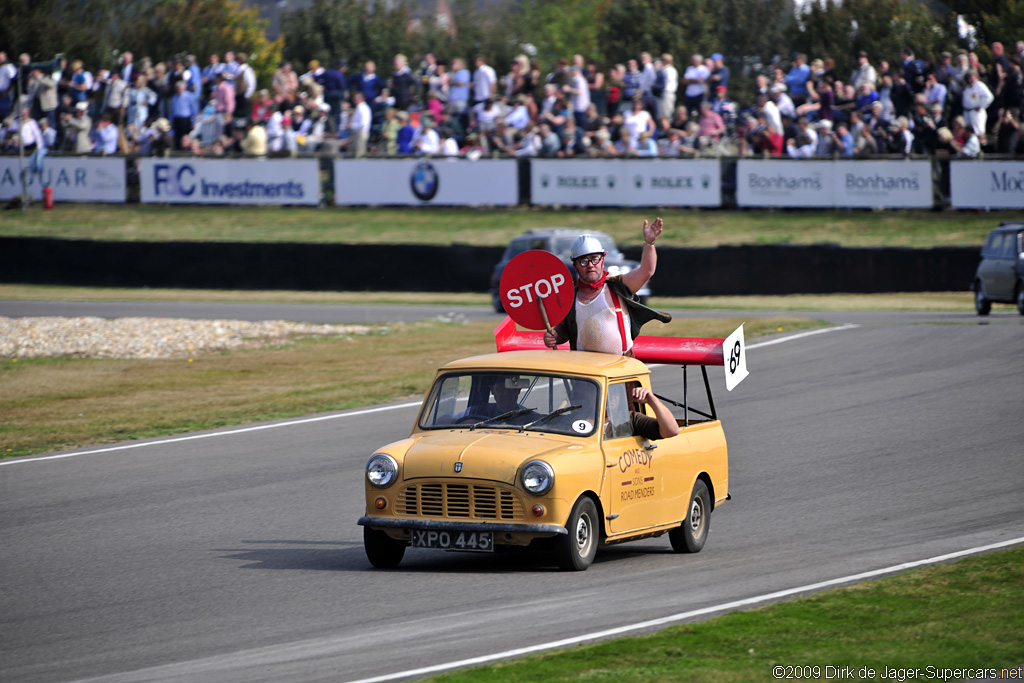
[358,321,745,570]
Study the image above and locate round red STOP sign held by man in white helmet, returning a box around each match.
[498,249,575,330]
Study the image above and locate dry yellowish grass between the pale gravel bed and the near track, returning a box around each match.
[0,316,820,457]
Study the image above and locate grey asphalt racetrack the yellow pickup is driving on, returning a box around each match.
[0,302,1024,683]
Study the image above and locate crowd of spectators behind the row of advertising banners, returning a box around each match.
[0,41,1024,158]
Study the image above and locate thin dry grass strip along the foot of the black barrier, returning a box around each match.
[0,285,974,312]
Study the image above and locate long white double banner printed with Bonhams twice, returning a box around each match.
[736,159,932,209]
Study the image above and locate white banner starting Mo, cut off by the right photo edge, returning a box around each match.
[949,161,1024,209]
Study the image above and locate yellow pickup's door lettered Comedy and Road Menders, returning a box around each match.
[602,381,664,533]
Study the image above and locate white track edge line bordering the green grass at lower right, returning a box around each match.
[349,537,1024,683]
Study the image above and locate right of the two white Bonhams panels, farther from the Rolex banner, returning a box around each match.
[833,160,933,209]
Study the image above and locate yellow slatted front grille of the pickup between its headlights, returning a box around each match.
[395,483,524,520]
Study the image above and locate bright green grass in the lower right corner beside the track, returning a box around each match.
[429,548,1024,683]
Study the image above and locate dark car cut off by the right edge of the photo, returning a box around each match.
[971,222,1024,315]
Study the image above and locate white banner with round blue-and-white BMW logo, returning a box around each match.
[334,158,519,206]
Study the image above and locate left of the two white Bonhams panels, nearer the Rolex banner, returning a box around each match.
[736,159,836,208]
